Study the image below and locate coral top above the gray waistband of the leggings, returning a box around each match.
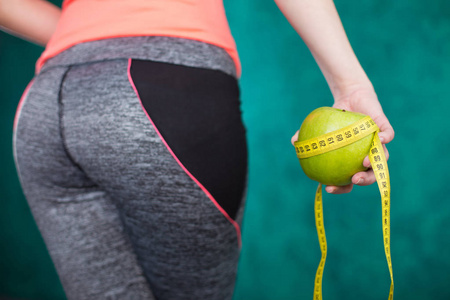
[36,0,241,74]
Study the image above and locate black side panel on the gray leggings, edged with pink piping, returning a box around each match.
[130,60,247,219]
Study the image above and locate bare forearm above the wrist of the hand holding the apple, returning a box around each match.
[275,0,371,98]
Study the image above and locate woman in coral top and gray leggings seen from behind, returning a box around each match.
[0,0,394,300]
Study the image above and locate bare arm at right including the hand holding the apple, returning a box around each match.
[275,0,394,193]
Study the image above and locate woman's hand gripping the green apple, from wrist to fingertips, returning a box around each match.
[291,86,394,194]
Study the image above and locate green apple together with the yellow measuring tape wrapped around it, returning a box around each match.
[294,107,394,300]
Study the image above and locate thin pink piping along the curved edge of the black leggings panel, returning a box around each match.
[127,58,242,248]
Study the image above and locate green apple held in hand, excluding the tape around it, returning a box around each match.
[298,107,375,186]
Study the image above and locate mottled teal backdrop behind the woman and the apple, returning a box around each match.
[0,0,450,300]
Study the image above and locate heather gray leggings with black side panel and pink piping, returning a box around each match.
[14,39,247,300]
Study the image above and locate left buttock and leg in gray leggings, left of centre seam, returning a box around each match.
[14,68,154,300]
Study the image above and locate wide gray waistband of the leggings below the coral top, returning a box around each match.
[40,36,237,77]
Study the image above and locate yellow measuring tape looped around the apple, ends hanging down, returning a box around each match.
[294,116,394,300]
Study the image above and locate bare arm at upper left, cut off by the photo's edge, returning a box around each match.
[0,0,61,46]
